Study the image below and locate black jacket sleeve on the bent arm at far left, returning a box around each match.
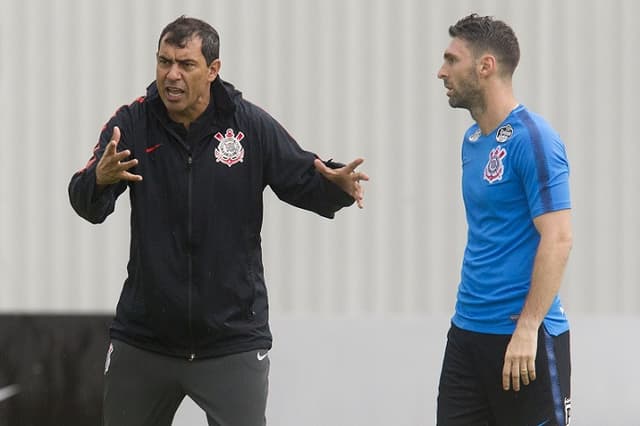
[69,107,130,223]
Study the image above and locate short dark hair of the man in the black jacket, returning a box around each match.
[158,15,220,65]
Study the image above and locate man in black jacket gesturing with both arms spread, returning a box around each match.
[69,17,368,426]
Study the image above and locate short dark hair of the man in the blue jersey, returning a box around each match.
[449,13,520,75]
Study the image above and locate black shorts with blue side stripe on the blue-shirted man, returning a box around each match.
[437,325,571,426]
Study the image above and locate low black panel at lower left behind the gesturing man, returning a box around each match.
[0,314,112,426]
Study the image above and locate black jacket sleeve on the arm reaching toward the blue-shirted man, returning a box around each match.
[260,105,355,219]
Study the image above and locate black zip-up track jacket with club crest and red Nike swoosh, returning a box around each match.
[69,77,354,359]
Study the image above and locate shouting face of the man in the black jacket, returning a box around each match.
[156,35,220,125]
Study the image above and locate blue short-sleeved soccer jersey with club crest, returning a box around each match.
[452,106,571,335]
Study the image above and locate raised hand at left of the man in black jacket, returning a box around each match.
[96,127,142,186]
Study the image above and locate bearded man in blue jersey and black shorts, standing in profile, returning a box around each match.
[437,14,572,426]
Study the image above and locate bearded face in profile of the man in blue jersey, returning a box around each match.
[438,38,482,110]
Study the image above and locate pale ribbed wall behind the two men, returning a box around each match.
[0,0,640,426]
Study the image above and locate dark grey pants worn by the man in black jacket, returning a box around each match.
[103,340,269,426]
